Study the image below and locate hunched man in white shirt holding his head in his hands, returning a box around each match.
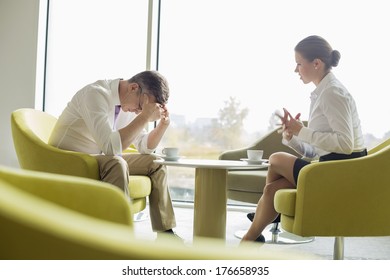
[49,71,176,236]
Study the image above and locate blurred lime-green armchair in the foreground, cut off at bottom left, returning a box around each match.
[0,166,316,260]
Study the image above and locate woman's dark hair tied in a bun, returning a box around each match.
[294,36,341,70]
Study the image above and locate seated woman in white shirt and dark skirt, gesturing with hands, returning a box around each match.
[242,36,367,242]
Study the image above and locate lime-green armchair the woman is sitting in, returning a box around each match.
[275,139,390,259]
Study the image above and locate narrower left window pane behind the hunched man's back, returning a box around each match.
[45,0,148,116]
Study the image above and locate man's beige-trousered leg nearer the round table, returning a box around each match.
[122,154,176,231]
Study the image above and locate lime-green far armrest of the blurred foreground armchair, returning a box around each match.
[0,167,132,225]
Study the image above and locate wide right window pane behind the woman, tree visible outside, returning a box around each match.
[159,0,390,201]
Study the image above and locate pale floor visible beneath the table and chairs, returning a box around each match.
[134,205,390,260]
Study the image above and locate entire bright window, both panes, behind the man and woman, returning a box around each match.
[46,0,390,203]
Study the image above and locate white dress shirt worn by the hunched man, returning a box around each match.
[49,79,153,155]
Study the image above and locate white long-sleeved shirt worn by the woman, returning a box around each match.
[283,73,365,158]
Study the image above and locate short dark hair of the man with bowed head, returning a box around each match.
[129,71,169,105]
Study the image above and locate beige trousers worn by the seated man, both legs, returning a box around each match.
[96,154,176,231]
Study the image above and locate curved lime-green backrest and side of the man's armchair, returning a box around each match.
[11,108,99,179]
